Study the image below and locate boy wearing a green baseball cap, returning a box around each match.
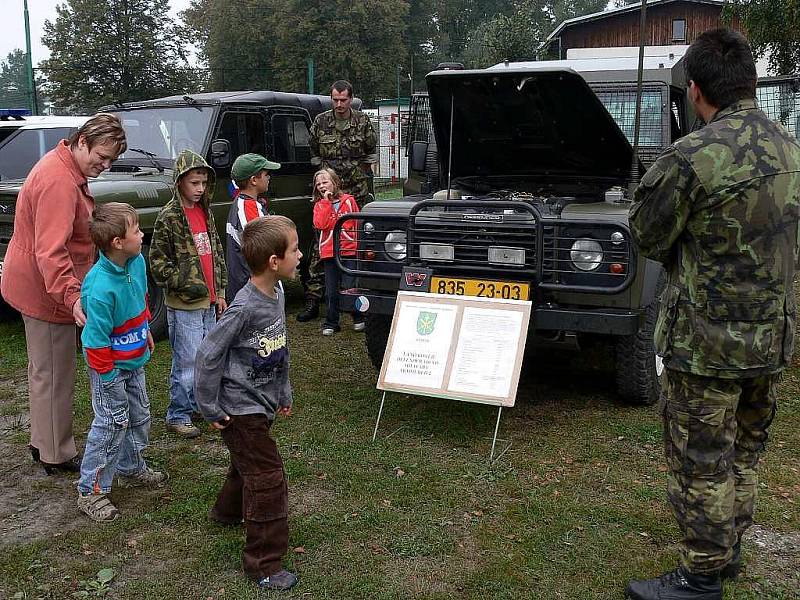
[225,153,281,304]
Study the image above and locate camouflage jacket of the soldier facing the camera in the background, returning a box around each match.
[309,108,377,206]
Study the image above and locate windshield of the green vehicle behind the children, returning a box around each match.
[115,106,214,158]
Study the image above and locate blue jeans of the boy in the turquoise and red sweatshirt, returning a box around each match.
[78,368,150,494]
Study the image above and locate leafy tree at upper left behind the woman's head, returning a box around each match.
[41,0,198,111]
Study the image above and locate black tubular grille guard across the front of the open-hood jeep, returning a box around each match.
[333,199,638,295]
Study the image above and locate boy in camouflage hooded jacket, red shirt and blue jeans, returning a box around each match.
[150,150,227,438]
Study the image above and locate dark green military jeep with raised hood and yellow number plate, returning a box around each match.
[334,63,672,404]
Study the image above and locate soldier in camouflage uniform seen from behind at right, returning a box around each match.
[627,29,800,600]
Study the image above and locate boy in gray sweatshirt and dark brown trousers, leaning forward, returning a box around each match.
[194,216,303,590]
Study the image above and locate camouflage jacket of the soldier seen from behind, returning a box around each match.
[630,100,800,378]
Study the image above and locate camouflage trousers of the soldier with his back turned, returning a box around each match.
[664,369,779,574]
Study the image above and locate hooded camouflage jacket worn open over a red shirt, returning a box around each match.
[150,150,228,310]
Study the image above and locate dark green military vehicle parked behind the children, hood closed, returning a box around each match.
[0,91,361,337]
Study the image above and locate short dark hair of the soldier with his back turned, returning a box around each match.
[683,28,758,109]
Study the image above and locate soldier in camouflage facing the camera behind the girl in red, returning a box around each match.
[297,80,378,322]
